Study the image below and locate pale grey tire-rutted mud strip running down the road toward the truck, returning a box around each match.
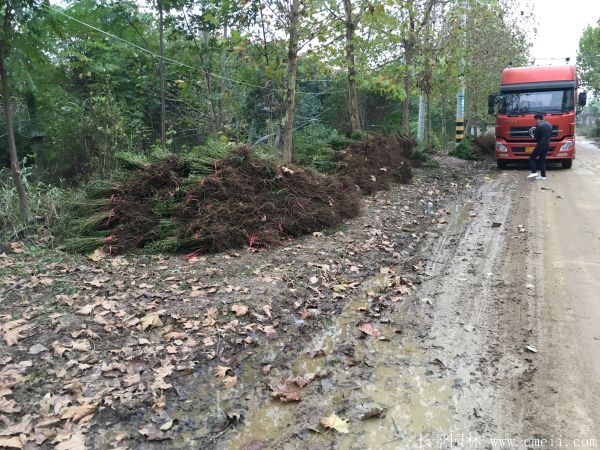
[412,171,536,442]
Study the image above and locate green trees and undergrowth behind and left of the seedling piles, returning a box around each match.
[0,0,530,249]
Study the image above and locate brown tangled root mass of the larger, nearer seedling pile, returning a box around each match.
[176,148,360,253]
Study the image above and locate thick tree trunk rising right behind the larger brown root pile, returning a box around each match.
[282,0,300,164]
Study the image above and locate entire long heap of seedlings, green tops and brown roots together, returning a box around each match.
[65,136,414,254]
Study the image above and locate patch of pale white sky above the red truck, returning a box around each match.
[519,0,600,65]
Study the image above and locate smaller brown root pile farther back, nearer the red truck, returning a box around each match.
[335,135,415,194]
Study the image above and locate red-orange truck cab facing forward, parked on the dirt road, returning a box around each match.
[488,65,587,169]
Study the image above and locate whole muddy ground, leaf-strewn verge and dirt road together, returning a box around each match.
[0,149,600,450]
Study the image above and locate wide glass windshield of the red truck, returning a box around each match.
[498,89,575,115]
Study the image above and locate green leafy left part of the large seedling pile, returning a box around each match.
[65,146,230,253]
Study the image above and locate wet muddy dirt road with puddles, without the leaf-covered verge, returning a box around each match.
[221,143,600,449]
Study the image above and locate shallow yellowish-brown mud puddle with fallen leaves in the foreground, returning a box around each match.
[222,275,452,450]
